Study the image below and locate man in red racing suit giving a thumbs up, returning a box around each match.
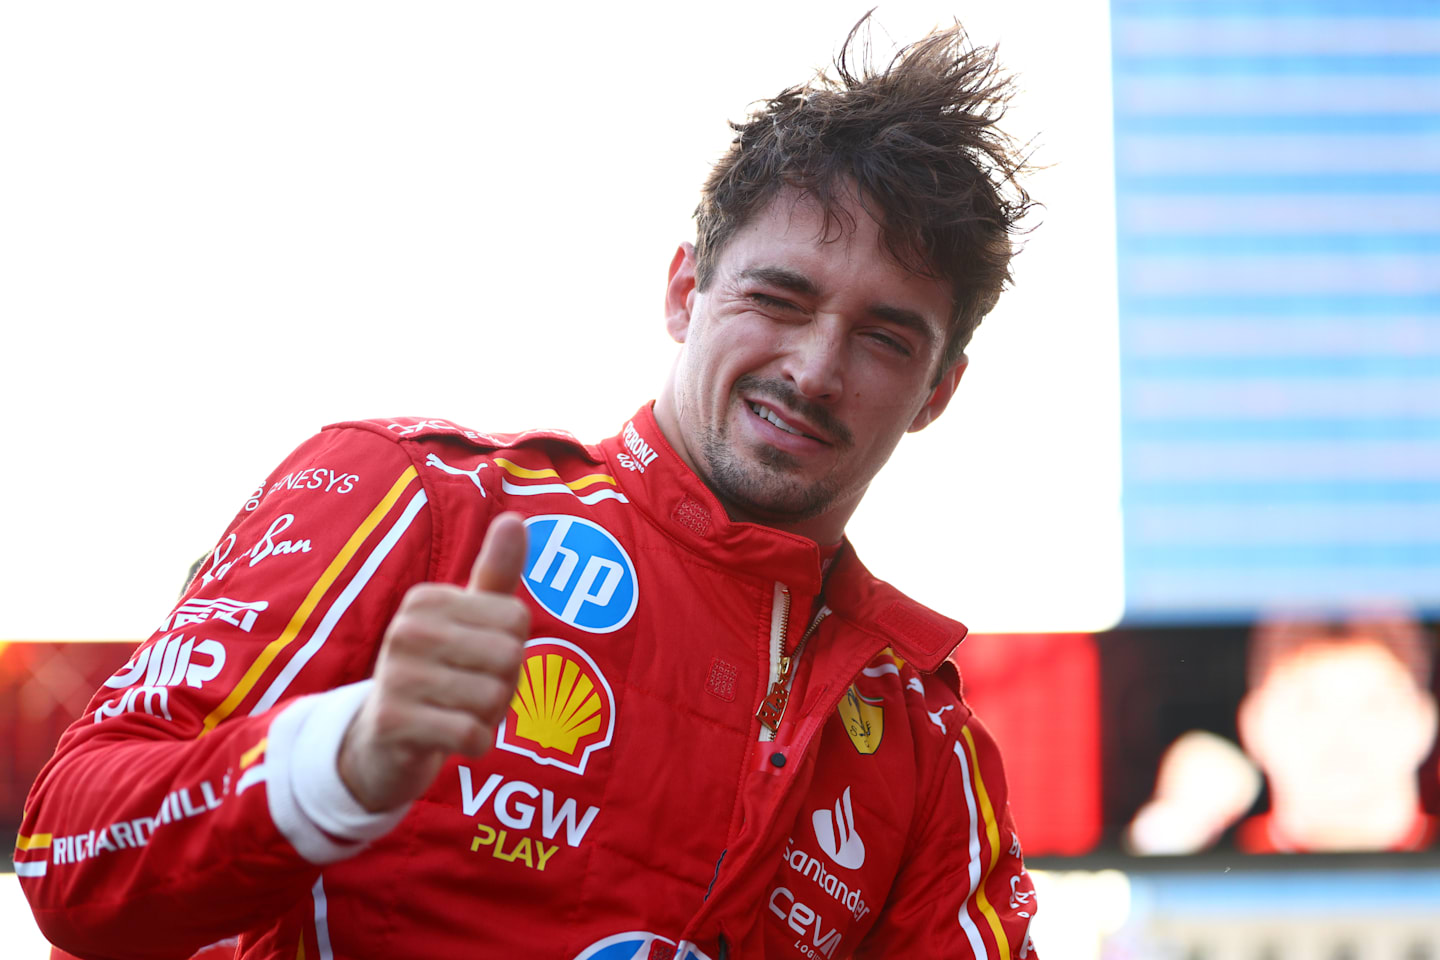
[16,16,1034,960]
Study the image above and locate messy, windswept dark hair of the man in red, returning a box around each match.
[696,13,1032,373]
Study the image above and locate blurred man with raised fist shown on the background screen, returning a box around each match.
[1125,613,1437,855]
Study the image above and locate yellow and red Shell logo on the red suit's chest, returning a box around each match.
[495,636,615,773]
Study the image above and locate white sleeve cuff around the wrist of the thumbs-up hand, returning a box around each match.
[265,679,410,864]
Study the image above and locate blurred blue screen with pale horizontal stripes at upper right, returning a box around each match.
[1112,0,1440,622]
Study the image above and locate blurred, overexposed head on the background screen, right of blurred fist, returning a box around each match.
[1236,613,1436,853]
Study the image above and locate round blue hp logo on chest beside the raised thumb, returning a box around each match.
[521,514,639,633]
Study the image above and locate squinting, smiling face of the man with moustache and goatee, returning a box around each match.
[657,191,963,543]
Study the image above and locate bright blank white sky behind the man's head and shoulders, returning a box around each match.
[0,0,1123,640]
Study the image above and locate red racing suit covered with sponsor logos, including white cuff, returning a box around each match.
[14,406,1034,960]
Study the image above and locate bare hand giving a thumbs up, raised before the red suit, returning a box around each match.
[337,514,530,813]
